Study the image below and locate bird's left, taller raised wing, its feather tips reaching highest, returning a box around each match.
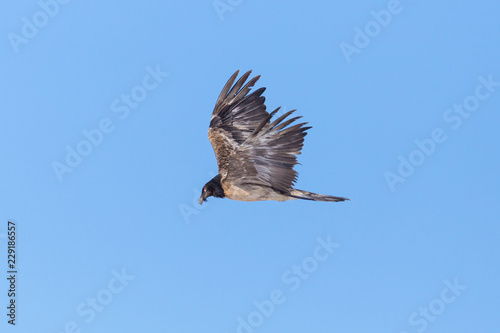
[208,71,269,178]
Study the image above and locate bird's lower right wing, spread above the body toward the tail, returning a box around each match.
[225,108,311,194]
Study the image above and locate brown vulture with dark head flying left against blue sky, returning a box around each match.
[198,70,350,205]
